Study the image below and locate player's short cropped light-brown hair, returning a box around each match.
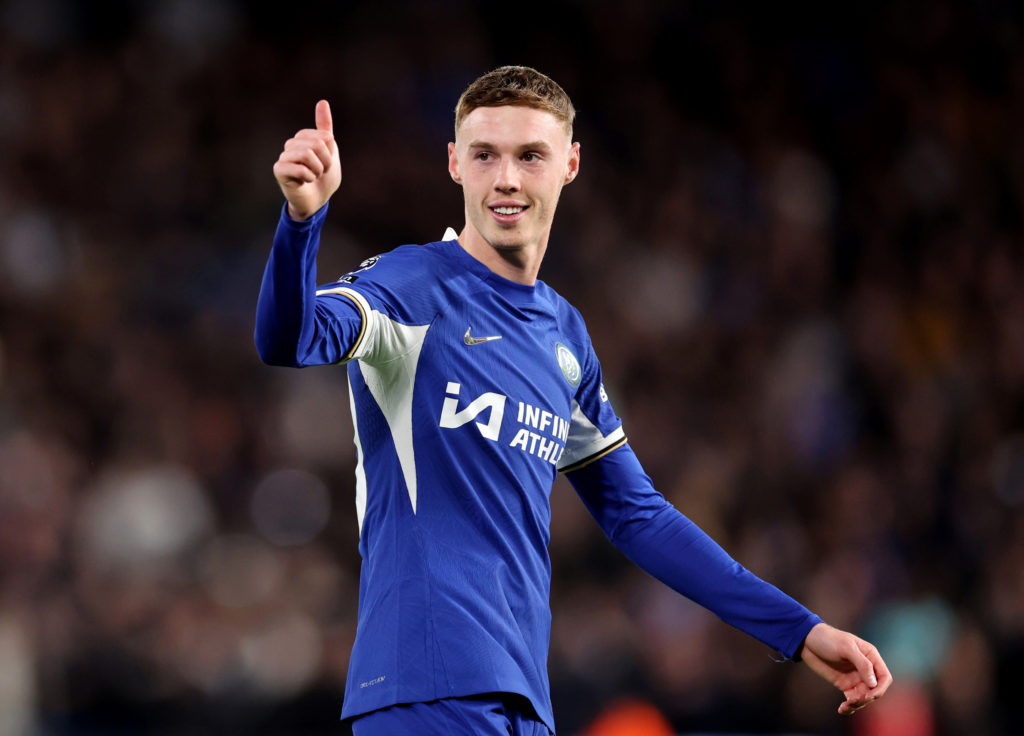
[455,67,575,136]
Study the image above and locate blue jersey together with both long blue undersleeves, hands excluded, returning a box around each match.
[256,202,820,732]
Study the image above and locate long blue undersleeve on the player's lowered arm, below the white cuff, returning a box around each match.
[566,444,821,659]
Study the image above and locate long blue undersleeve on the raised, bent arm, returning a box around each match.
[254,205,364,366]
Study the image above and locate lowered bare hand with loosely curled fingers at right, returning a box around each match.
[800,623,893,716]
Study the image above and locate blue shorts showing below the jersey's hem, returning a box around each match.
[352,693,550,736]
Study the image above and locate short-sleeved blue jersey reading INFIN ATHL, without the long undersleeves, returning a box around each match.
[317,234,625,726]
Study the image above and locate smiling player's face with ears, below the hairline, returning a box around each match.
[449,105,580,251]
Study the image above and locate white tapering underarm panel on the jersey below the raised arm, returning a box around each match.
[352,311,430,513]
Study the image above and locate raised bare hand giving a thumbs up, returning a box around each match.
[273,99,341,220]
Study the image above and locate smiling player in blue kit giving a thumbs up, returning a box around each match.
[255,67,892,736]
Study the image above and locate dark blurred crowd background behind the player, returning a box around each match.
[0,0,1024,736]
